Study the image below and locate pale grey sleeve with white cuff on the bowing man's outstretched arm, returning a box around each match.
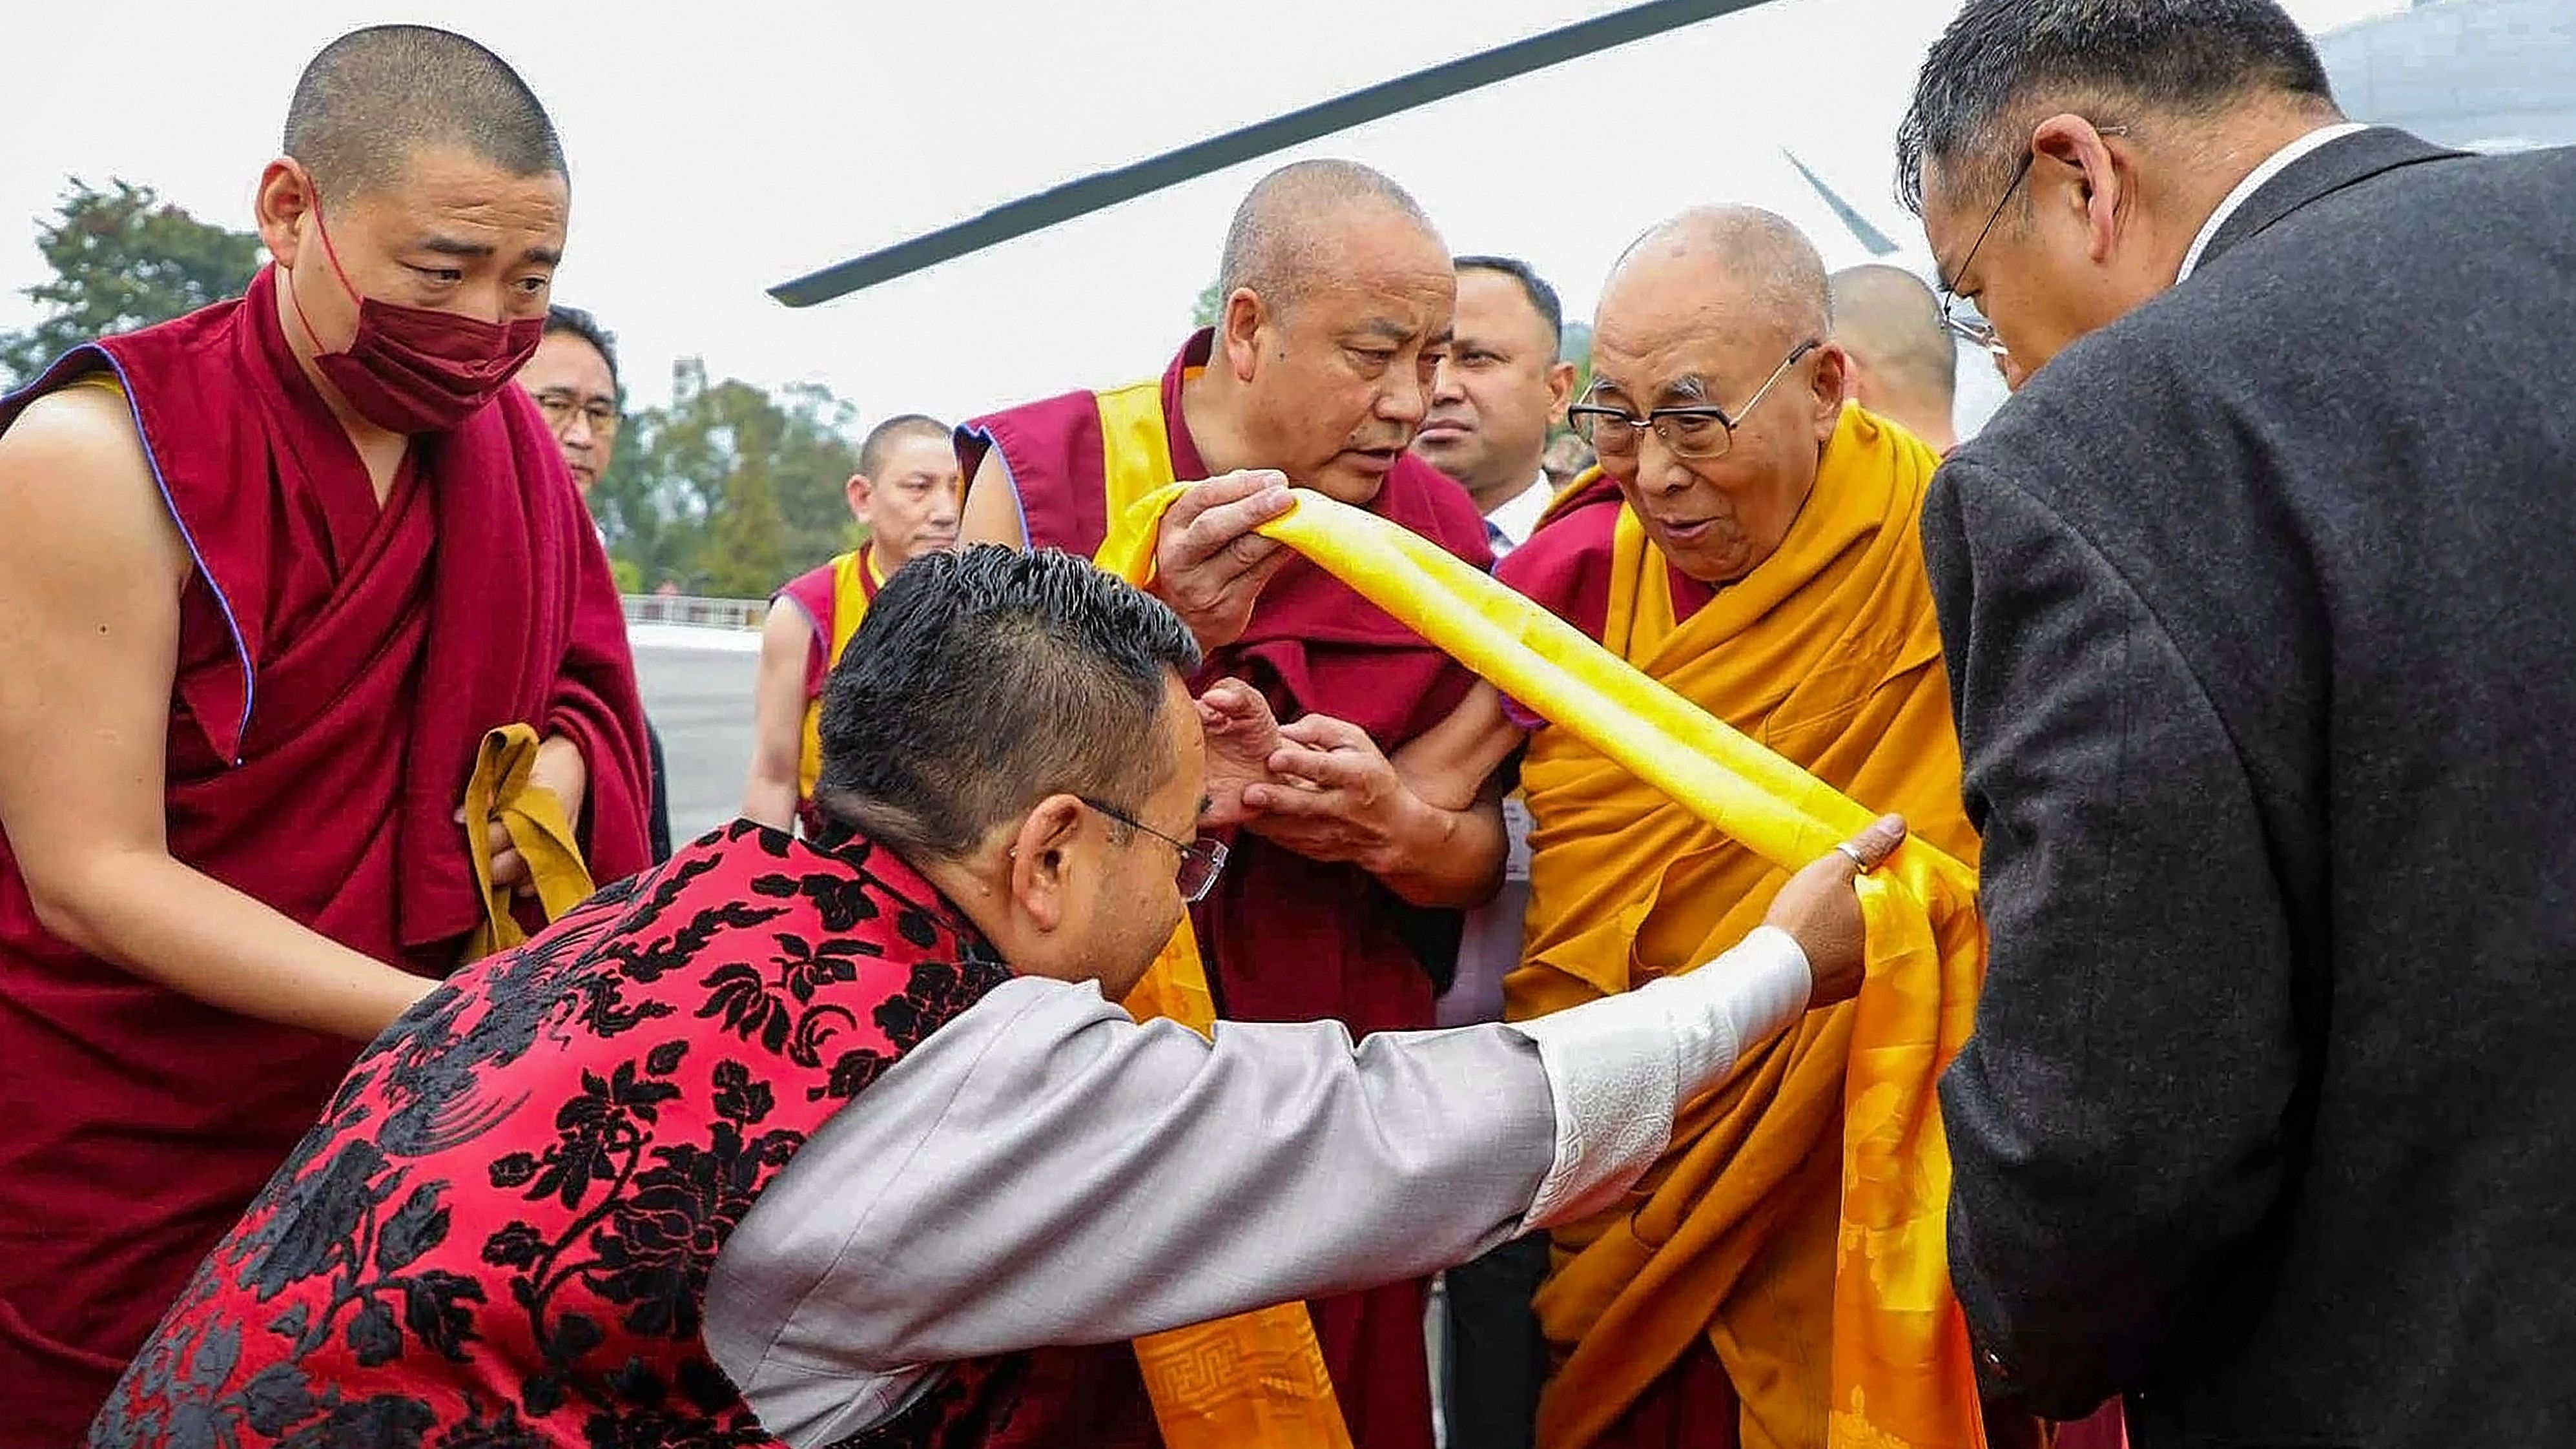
[706,932,1808,1444]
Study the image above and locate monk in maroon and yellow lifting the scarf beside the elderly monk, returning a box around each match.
[958,162,1505,1449]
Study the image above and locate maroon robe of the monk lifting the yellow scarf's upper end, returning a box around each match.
[958,332,1492,1449]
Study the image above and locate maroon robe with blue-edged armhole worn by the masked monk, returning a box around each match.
[0,271,649,1449]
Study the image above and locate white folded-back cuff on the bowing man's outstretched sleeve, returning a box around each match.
[1512,927,1813,1228]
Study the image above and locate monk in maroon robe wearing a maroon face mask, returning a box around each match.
[0,26,649,1449]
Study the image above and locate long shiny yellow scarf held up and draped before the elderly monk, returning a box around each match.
[1097,435,1984,1449]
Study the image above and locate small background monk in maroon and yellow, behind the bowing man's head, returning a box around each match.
[742,412,958,831]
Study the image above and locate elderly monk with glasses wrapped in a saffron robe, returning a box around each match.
[1406,209,1976,1449]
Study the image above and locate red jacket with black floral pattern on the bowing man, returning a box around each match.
[90,821,1015,1449]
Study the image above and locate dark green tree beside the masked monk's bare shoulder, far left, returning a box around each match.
[0,178,260,381]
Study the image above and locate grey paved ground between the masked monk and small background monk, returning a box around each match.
[631,626,760,841]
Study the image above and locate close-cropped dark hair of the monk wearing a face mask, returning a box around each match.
[283,26,564,198]
